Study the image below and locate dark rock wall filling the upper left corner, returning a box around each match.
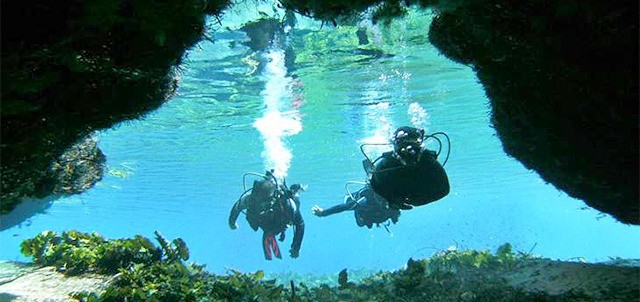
[0,0,229,213]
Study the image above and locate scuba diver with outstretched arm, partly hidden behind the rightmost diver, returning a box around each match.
[311,183,400,231]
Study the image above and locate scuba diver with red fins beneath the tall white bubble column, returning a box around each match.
[229,170,304,260]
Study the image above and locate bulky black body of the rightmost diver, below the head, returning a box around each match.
[370,149,449,208]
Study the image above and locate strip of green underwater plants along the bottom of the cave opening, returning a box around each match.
[16,231,640,301]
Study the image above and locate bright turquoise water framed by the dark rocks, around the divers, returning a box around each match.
[0,7,640,274]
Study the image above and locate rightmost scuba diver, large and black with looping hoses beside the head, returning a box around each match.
[360,126,451,210]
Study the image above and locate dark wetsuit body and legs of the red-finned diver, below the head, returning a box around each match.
[229,189,304,260]
